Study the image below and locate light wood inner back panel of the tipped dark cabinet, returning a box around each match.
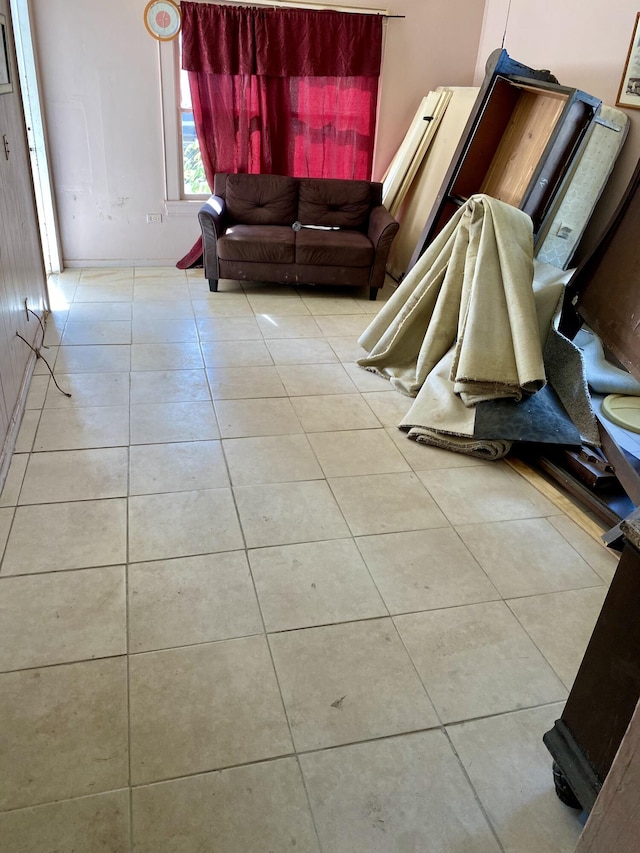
[480,88,567,207]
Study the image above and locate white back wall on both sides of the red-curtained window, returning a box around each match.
[31,0,484,266]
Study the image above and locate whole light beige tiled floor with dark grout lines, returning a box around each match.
[0,267,616,853]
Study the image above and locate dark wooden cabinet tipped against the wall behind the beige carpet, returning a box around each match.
[410,50,601,266]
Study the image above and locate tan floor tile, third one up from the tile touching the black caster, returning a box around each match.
[329,473,449,536]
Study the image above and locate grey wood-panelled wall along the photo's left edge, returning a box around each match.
[0,0,47,480]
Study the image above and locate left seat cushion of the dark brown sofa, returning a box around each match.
[217,225,295,264]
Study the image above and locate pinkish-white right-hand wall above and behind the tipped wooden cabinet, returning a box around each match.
[475,0,640,254]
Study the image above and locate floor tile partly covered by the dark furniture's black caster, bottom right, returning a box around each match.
[448,705,582,853]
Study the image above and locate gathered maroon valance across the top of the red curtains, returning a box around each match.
[181,0,382,77]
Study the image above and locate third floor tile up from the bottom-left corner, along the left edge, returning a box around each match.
[0,566,127,671]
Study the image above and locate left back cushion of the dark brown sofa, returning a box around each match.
[225,175,298,225]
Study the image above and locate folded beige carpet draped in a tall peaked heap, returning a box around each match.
[358,195,546,458]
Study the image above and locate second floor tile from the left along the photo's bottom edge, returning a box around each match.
[133,758,319,853]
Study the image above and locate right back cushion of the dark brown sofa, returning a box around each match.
[297,178,371,231]
